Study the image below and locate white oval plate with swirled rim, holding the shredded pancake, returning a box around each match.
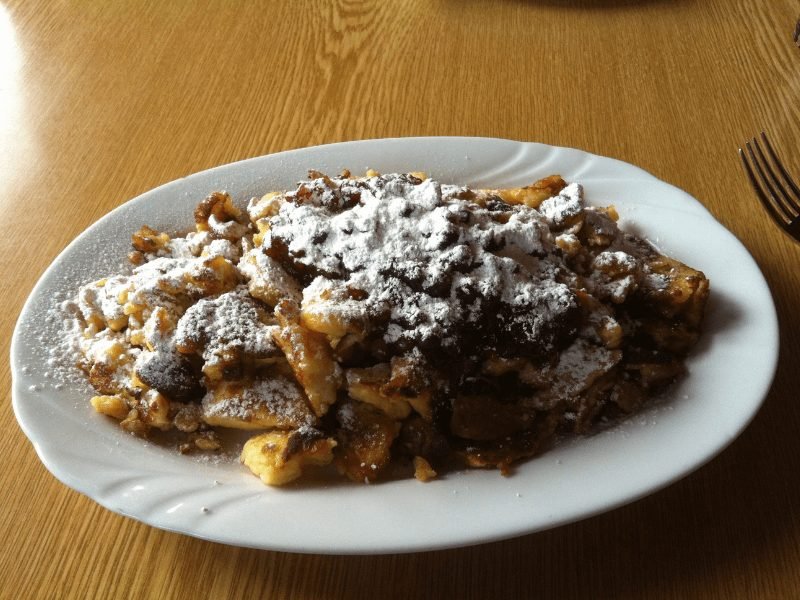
[11,138,778,554]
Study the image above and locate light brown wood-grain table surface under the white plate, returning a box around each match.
[0,0,800,599]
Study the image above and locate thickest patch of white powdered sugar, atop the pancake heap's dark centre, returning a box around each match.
[264,175,581,354]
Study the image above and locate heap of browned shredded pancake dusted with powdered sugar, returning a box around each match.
[65,171,709,485]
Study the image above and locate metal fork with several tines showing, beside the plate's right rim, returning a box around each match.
[739,131,800,242]
